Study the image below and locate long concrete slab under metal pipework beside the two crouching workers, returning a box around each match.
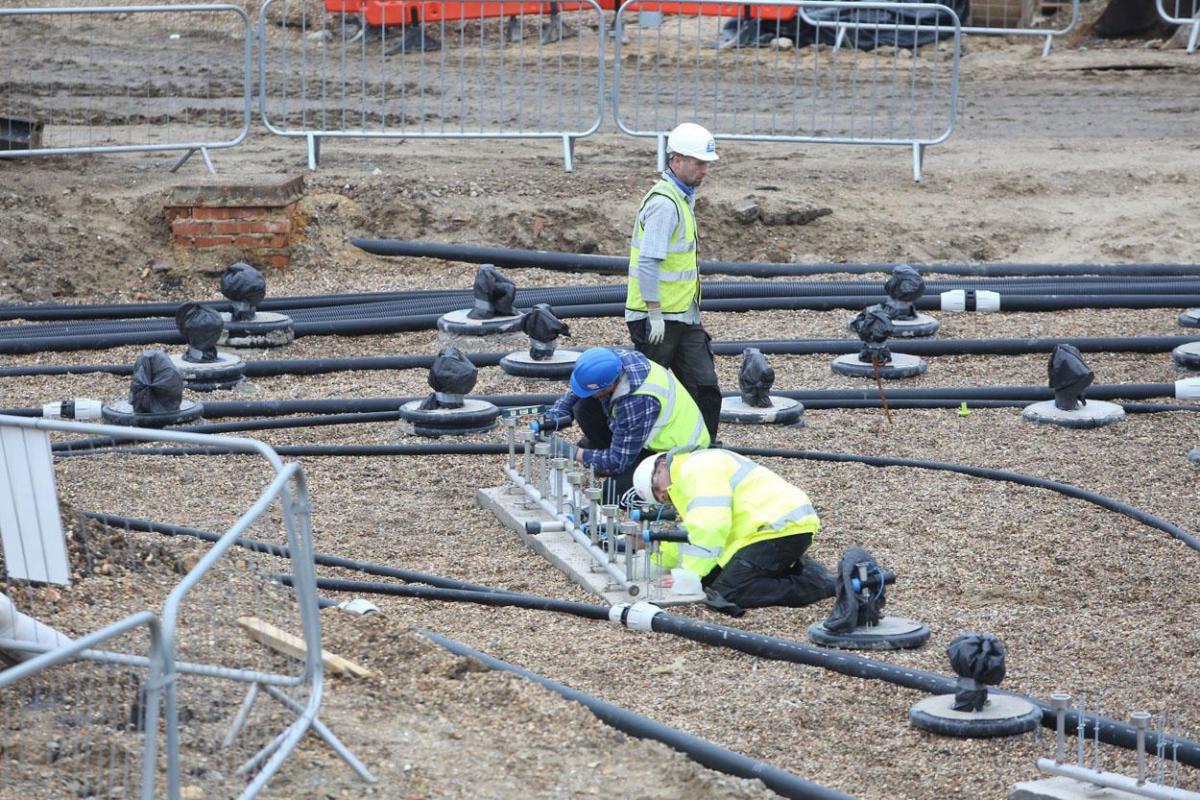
[475,486,704,606]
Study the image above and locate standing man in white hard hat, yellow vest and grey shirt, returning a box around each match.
[625,122,721,440]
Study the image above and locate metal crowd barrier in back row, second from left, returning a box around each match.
[259,0,605,172]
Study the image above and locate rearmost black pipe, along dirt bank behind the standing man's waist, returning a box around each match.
[350,236,1200,277]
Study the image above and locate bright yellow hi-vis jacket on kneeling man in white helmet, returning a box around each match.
[661,450,821,577]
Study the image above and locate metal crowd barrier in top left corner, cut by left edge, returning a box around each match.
[0,4,253,172]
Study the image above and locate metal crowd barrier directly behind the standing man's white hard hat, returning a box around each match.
[612,0,961,181]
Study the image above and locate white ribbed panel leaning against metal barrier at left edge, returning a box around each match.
[0,426,71,585]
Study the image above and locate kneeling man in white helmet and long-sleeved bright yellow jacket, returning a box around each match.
[634,450,835,614]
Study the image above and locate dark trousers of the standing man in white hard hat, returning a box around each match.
[625,319,721,441]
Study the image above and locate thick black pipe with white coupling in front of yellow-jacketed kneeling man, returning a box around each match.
[302,581,1200,766]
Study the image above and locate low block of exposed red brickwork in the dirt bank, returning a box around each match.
[163,176,304,266]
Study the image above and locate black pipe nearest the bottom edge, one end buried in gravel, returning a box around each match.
[421,630,853,800]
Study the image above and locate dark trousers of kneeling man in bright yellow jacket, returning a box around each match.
[703,534,836,608]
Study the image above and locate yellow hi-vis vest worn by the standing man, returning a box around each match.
[625,180,700,314]
